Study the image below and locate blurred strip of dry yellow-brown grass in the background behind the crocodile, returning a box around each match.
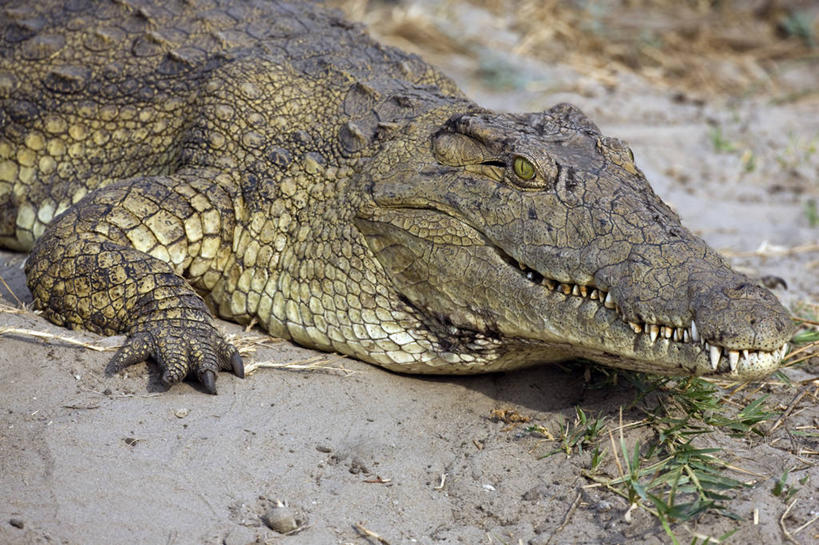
[331,0,819,95]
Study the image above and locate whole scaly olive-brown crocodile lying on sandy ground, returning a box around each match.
[0,0,793,392]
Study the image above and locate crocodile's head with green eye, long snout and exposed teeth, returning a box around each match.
[357,104,793,378]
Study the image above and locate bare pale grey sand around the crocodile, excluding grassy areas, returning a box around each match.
[0,1,819,545]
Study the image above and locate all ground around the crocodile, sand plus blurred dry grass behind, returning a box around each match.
[0,2,819,545]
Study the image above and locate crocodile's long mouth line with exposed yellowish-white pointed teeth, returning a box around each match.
[502,258,788,374]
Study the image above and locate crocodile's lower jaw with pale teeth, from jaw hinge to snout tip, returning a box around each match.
[357,209,787,380]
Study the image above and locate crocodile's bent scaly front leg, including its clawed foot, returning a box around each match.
[26,171,244,393]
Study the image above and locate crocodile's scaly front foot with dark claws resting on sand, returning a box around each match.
[106,321,245,394]
